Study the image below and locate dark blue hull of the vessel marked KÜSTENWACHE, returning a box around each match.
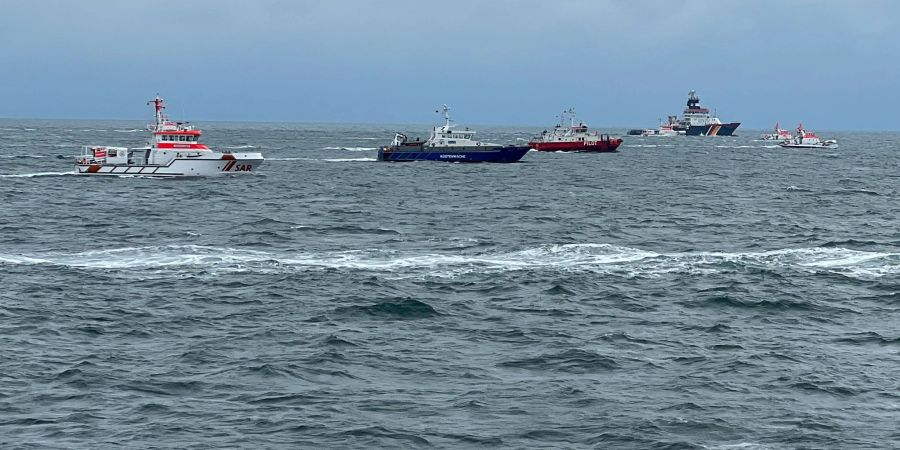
[378,145,530,163]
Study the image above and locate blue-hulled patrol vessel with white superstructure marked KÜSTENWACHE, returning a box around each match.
[378,105,530,163]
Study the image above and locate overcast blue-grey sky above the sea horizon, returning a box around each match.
[0,0,900,130]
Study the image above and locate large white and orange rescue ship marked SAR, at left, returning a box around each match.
[75,96,265,177]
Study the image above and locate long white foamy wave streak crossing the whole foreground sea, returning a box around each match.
[0,244,900,279]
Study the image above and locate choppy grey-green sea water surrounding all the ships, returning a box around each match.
[0,120,900,448]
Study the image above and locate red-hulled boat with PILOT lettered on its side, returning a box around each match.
[528,108,622,152]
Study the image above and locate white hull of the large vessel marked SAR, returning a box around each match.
[75,153,265,178]
